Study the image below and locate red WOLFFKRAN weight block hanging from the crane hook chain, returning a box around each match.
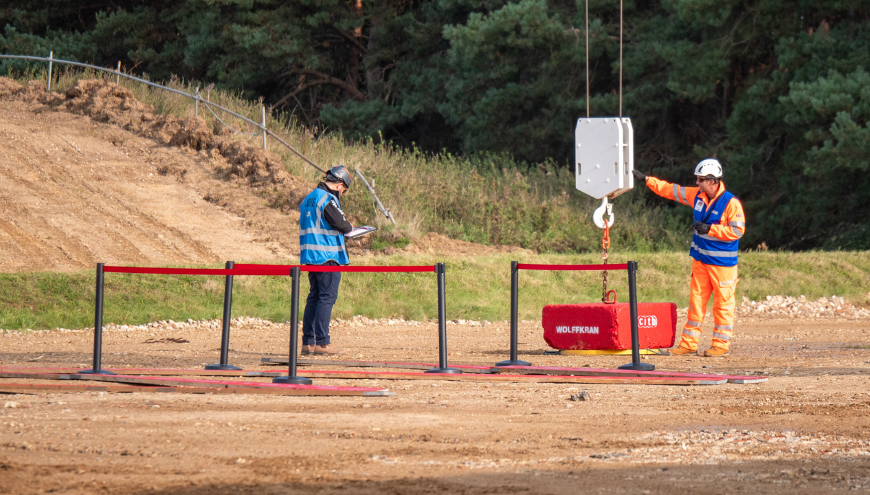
[542,303,677,351]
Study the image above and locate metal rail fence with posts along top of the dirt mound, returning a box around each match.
[0,52,326,174]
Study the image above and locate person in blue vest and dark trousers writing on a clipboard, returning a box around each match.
[299,165,353,354]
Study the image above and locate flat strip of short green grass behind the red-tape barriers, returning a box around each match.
[0,252,870,329]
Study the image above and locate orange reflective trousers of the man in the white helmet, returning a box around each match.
[680,260,737,351]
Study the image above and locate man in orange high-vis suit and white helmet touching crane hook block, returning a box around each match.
[634,158,746,357]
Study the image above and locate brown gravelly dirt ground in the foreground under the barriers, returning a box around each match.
[0,304,870,495]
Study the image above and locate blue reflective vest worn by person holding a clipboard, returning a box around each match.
[299,188,350,265]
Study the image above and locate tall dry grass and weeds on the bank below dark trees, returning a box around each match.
[10,65,691,253]
